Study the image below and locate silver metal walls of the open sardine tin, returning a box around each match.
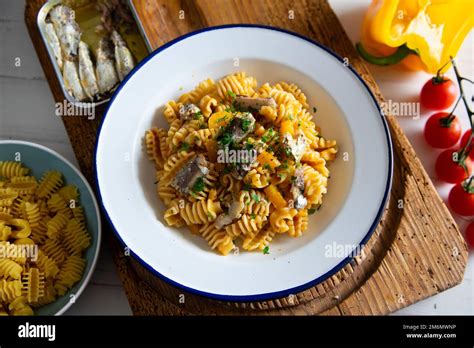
[37,0,152,108]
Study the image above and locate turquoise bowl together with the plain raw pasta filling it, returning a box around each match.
[0,141,100,315]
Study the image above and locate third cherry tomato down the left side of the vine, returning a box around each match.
[435,150,474,184]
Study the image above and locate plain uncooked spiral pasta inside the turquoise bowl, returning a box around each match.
[0,161,90,315]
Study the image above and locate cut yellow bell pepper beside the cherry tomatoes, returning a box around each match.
[357,0,474,74]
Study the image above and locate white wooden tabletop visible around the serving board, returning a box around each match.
[0,0,474,315]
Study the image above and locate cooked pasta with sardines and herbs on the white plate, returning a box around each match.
[145,72,337,255]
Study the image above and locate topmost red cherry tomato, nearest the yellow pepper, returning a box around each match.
[420,76,457,110]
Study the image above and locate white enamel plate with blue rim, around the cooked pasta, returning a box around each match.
[96,25,392,301]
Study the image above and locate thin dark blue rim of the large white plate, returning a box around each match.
[94,24,393,302]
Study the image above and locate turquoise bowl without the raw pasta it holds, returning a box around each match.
[0,140,102,315]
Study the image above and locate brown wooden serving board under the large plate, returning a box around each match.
[25,0,468,315]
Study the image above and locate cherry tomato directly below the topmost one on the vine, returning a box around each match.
[425,112,461,149]
